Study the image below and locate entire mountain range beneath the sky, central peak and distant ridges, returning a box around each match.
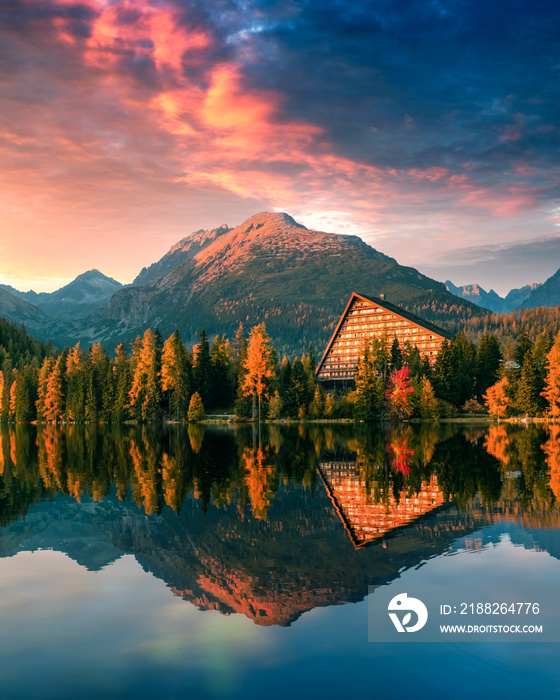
[0,212,560,353]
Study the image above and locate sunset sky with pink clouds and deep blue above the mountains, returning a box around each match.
[0,0,560,294]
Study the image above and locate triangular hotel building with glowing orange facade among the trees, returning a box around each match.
[317,292,451,382]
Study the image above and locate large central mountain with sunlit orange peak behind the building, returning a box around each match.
[70,212,483,352]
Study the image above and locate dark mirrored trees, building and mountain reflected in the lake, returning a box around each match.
[0,418,560,625]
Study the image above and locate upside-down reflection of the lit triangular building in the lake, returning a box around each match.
[318,461,445,549]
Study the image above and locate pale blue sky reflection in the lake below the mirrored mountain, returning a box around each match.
[0,526,560,700]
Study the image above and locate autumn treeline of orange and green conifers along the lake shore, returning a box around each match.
[0,314,560,423]
